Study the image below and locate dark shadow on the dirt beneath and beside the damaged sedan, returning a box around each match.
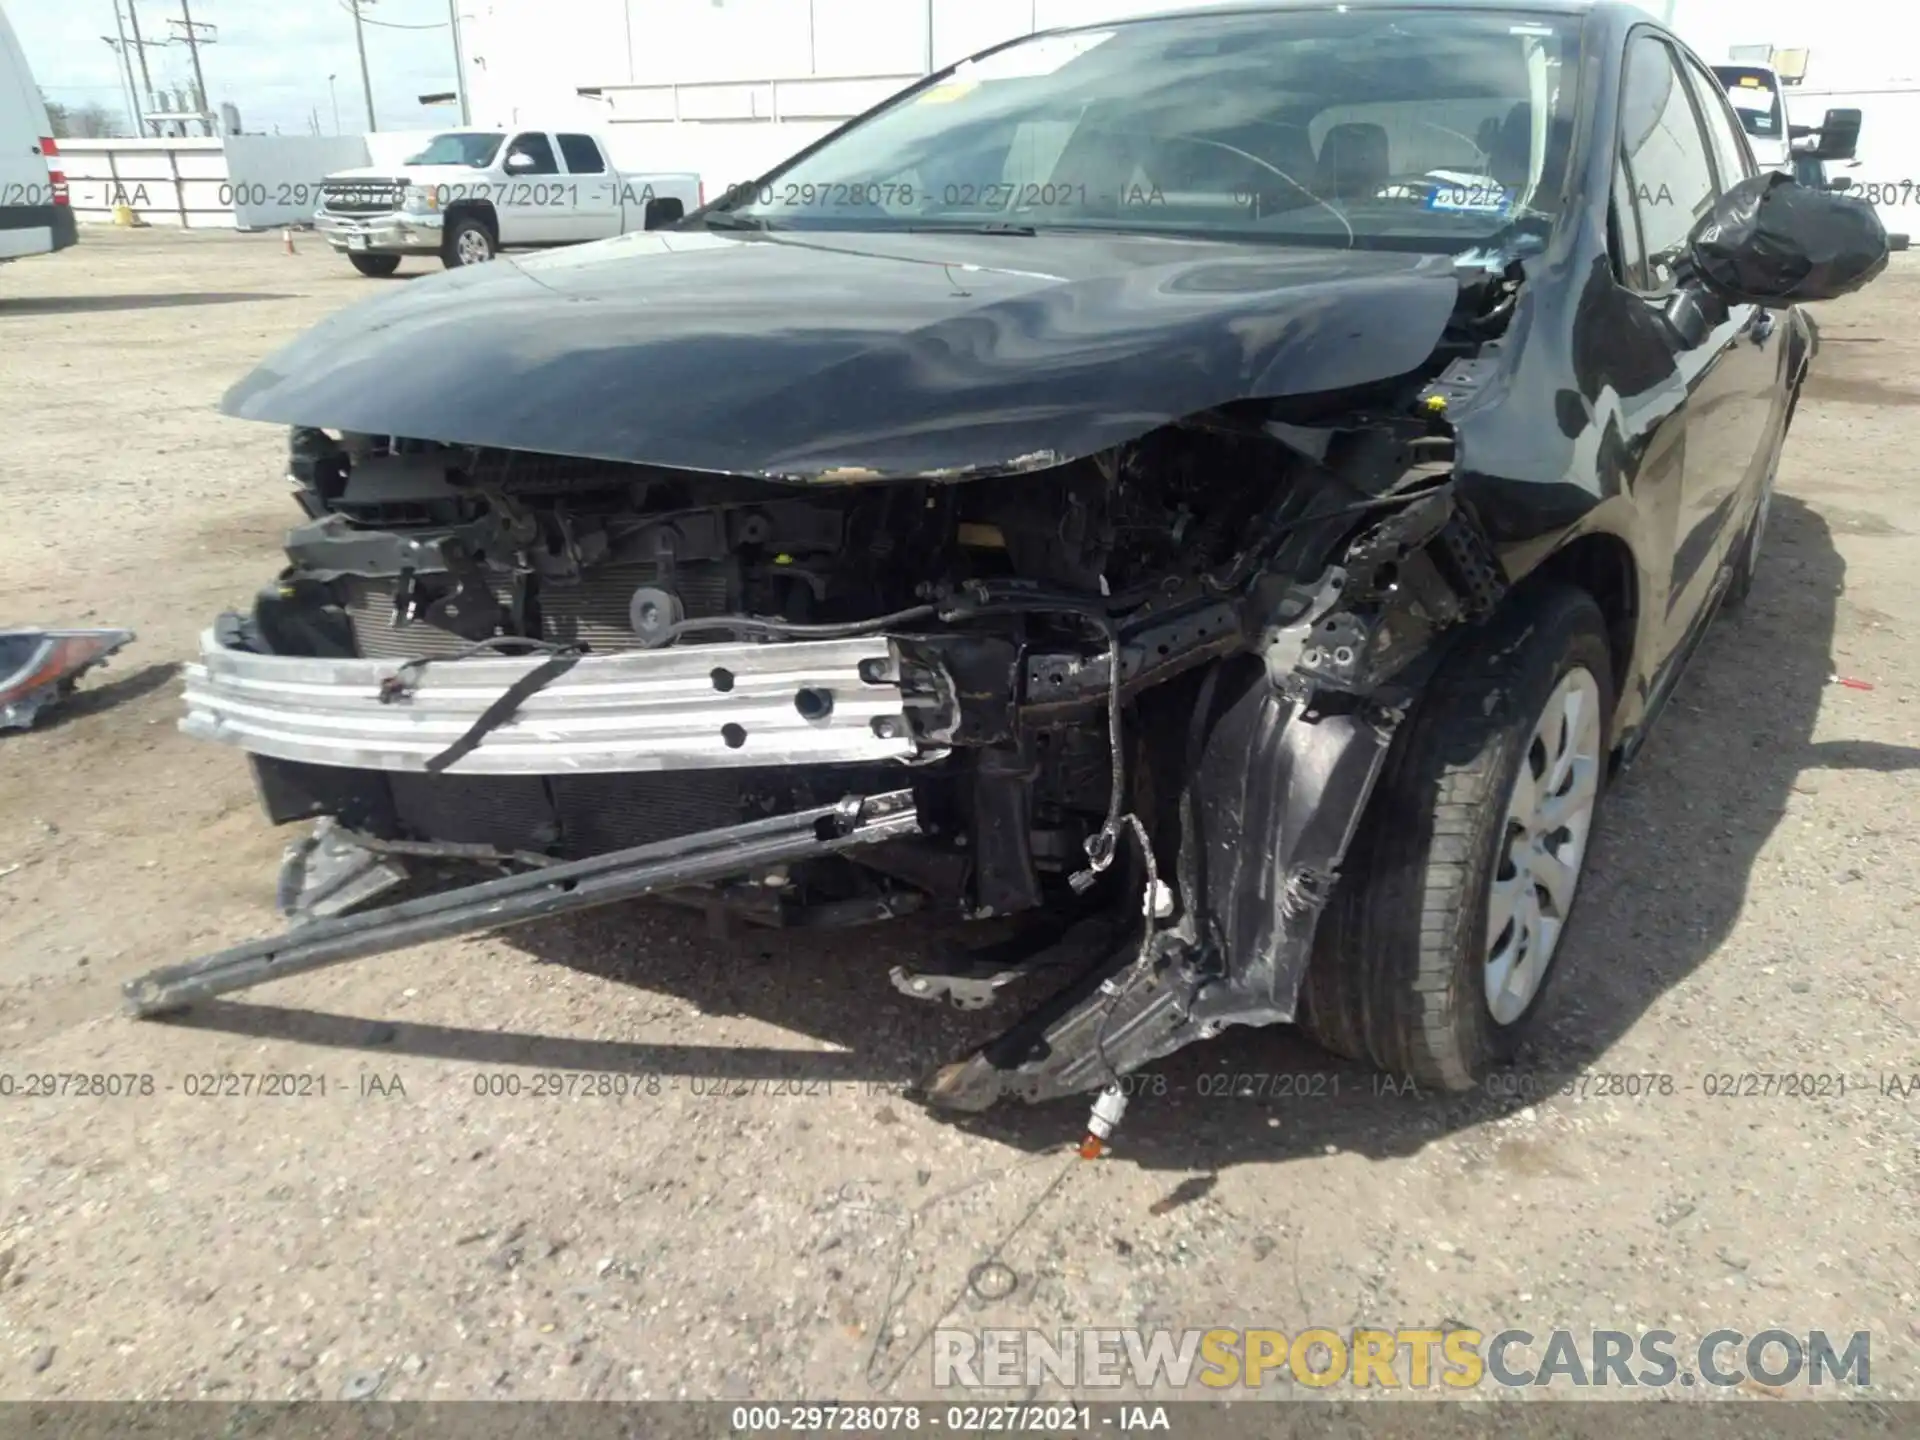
[175,495,1920,1171]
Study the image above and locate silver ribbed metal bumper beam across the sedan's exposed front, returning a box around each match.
[180,630,947,776]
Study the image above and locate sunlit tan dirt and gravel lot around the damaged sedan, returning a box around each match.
[0,230,1920,1400]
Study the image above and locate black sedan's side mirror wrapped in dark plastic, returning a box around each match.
[1682,171,1887,305]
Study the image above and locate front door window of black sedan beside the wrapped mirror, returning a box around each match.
[1620,33,1718,290]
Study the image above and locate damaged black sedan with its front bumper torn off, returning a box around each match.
[129,4,1885,1119]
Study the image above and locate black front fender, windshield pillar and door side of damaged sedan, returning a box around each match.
[1413,4,1809,753]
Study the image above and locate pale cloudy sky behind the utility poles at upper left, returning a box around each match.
[0,0,472,134]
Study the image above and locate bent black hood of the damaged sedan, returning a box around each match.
[221,230,1457,482]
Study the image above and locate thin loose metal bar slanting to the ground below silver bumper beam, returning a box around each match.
[125,789,920,1016]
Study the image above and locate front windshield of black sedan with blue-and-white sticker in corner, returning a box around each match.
[718,8,1578,250]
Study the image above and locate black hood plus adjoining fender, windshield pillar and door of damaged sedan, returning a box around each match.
[223,2,1805,768]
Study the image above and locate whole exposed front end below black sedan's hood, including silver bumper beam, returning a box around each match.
[136,359,1503,1108]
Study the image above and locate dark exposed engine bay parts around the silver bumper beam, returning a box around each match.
[236,389,1484,879]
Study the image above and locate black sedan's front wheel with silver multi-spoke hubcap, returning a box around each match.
[1302,586,1615,1091]
